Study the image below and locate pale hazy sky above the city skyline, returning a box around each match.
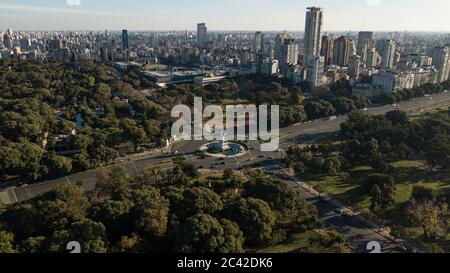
[0,0,450,32]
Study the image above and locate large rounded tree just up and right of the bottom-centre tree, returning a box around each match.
[223,198,276,246]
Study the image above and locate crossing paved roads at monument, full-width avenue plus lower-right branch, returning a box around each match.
[0,93,450,252]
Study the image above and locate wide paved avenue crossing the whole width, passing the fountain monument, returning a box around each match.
[0,93,450,204]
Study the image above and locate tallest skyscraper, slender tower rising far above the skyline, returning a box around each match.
[304,7,323,60]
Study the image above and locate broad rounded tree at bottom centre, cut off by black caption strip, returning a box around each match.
[174,214,244,253]
